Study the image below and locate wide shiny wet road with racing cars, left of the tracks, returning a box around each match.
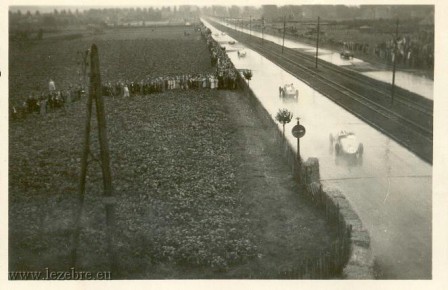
[204,21,432,279]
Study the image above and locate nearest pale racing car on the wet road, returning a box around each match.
[330,130,364,164]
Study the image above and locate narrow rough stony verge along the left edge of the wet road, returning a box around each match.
[239,75,375,280]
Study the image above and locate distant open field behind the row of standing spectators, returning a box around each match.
[9,27,213,105]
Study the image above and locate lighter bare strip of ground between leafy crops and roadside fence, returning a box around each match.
[222,91,331,273]
